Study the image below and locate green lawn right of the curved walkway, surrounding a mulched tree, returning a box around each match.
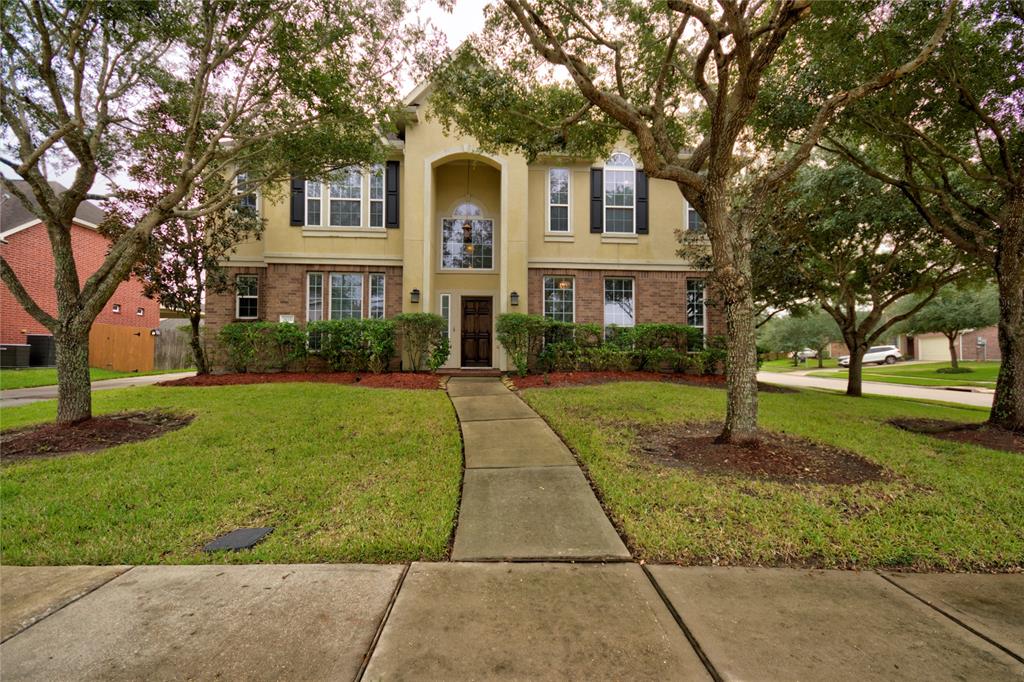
[524,383,1024,570]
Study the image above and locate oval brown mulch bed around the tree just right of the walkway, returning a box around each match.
[634,423,892,484]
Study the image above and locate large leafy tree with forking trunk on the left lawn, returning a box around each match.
[0,0,417,423]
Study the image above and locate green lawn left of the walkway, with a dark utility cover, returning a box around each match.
[0,383,462,564]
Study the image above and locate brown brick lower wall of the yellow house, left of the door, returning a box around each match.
[206,263,401,335]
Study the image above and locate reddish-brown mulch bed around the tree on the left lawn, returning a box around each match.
[0,411,193,463]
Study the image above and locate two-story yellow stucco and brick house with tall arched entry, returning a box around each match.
[207,86,724,370]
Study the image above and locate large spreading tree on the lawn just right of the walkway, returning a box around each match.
[432,0,954,440]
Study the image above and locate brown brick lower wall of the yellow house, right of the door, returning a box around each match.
[528,268,725,336]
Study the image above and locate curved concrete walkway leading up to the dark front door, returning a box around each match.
[447,377,630,561]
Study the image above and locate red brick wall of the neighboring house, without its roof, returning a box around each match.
[0,223,160,343]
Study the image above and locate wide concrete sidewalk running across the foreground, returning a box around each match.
[0,562,1024,682]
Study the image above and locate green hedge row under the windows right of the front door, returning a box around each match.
[498,313,725,376]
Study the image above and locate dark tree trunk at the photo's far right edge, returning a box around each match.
[988,196,1024,432]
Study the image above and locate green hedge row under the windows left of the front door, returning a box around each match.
[217,312,449,373]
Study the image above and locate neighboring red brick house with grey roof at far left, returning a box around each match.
[0,181,160,370]
